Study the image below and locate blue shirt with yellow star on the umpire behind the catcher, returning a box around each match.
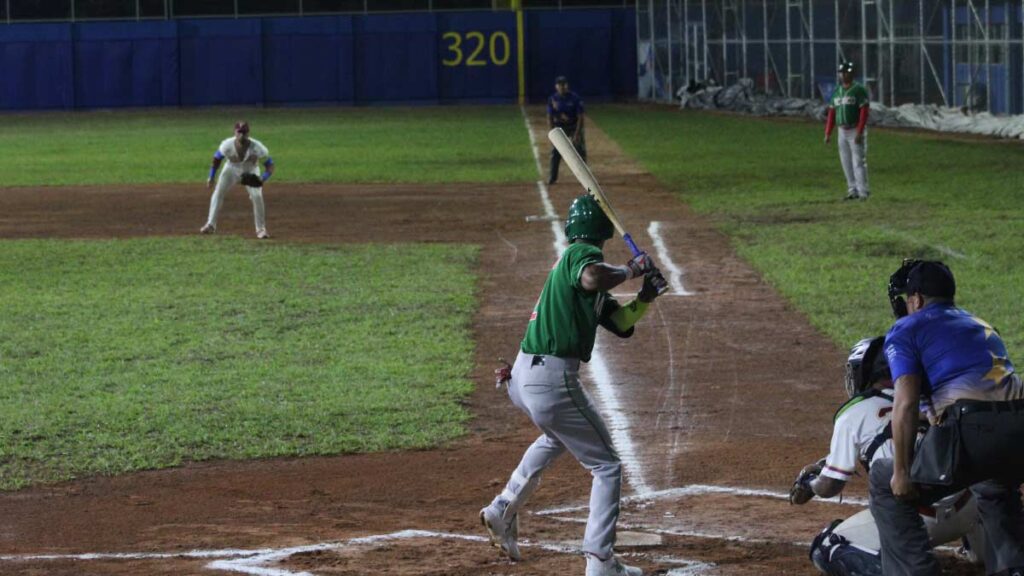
[885,302,1022,414]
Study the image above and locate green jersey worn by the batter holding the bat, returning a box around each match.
[521,242,614,362]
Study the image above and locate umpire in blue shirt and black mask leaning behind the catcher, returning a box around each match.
[869,260,1024,576]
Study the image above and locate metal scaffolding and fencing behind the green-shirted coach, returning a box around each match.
[637,0,1024,114]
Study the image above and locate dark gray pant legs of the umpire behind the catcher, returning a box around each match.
[868,458,1024,576]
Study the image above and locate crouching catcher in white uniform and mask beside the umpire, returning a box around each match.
[790,336,984,576]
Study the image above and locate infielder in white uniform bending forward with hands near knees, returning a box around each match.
[200,121,273,240]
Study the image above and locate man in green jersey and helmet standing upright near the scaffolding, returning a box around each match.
[825,61,871,200]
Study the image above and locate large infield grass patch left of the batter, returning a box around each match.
[0,238,476,489]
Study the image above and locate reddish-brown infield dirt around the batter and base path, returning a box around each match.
[0,113,981,575]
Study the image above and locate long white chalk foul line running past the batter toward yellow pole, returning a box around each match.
[519,107,651,494]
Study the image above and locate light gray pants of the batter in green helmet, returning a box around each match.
[503,352,622,559]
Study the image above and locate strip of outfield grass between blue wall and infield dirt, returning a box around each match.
[0,106,537,186]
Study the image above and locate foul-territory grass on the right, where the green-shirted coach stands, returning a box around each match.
[593,106,1024,358]
